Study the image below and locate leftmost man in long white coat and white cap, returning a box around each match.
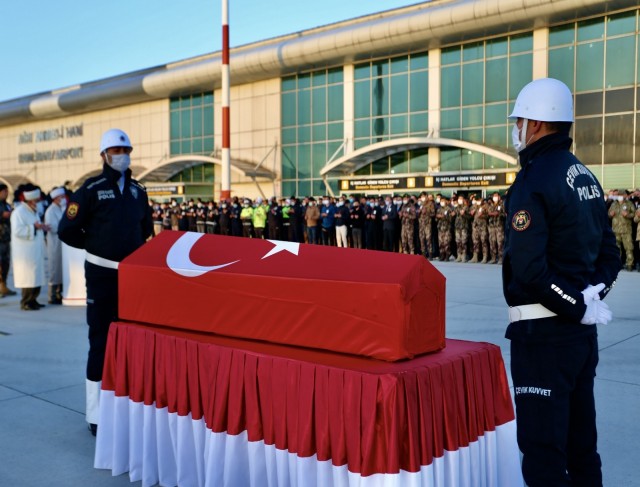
[11,186,48,311]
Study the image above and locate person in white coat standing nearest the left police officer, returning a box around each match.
[44,188,67,304]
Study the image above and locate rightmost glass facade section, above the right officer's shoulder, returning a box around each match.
[548,10,640,188]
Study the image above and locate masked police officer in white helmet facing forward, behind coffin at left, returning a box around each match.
[58,129,153,435]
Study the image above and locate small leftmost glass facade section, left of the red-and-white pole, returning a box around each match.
[169,92,213,157]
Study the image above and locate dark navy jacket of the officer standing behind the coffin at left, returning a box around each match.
[58,164,153,262]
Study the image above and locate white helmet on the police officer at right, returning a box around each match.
[509,78,573,122]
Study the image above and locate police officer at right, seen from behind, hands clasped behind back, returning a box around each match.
[502,78,621,487]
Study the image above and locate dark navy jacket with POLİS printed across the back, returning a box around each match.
[502,134,621,330]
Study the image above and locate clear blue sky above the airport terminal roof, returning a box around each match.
[0,0,420,101]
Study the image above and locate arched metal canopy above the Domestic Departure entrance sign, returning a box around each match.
[320,137,518,181]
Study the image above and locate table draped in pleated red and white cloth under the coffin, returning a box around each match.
[94,322,522,487]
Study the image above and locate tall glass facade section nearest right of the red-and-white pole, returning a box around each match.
[281,67,344,196]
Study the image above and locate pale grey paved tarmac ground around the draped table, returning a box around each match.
[0,262,640,487]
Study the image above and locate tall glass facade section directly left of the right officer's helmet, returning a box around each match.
[440,32,533,171]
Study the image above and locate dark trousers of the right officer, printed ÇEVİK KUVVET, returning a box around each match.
[511,330,602,487]
